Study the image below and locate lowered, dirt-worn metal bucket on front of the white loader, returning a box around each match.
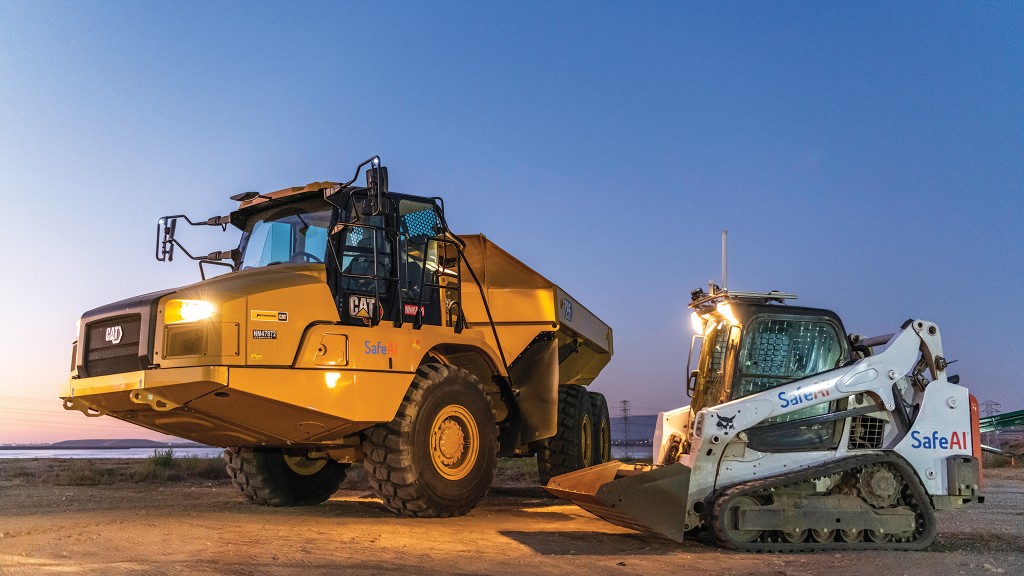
[545,460,690,542]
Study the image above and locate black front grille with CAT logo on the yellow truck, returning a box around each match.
[85,314,147,376]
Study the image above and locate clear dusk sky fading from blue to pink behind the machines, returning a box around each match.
[0,0,1024,443]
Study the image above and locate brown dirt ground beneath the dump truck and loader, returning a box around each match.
[0,459,1024,576]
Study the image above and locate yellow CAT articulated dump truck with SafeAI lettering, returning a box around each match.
[61,157,612,517]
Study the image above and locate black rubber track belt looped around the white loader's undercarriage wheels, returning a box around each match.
[710,453,936,552]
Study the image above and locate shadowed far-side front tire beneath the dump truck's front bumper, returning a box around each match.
[224,448,349,506]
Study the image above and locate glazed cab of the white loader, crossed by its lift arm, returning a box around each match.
[688,299,852,452]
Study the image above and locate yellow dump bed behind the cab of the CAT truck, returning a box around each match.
[462,234,612,384]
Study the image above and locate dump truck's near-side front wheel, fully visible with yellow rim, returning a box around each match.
[362,364,498,518]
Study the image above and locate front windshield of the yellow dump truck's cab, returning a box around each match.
[241,200,331,270]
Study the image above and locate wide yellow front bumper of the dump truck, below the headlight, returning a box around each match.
[61,366,412,447]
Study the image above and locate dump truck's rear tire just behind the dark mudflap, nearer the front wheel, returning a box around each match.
[537,384,594,484]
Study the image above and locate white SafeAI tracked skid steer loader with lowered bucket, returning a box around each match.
[547,285,984,551]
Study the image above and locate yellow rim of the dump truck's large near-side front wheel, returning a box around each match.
[430,404,480,480]
